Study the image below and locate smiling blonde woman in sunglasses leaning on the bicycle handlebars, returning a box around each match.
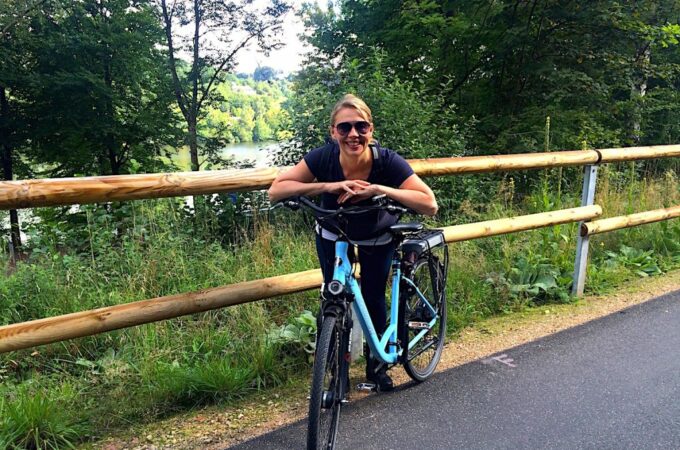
[269,94,438,391]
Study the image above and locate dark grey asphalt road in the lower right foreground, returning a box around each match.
[233,291,680,450]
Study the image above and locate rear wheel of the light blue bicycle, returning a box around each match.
[399,257,446,382]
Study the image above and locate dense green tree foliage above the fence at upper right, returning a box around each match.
[307,0,680,153]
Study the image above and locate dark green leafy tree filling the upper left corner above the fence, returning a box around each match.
[0,0,177,253]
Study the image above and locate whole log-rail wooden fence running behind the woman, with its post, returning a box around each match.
[0,145,680,353]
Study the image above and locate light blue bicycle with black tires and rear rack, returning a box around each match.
[282,196,448,450]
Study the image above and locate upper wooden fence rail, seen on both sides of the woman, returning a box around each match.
[0,145,680,210]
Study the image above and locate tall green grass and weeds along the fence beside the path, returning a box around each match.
[0,168,680,448]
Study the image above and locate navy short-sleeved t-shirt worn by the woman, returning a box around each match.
[304,142,414,239]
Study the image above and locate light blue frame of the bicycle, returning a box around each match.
[333,240,439,364]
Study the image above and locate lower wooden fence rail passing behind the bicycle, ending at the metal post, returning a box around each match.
[0,205,602,353]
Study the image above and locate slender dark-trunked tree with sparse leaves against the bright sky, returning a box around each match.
[160,0,290,170]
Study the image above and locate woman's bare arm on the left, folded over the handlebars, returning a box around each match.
[267,159,369,202]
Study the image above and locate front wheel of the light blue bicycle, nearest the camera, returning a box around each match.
[307,316,342,450]
